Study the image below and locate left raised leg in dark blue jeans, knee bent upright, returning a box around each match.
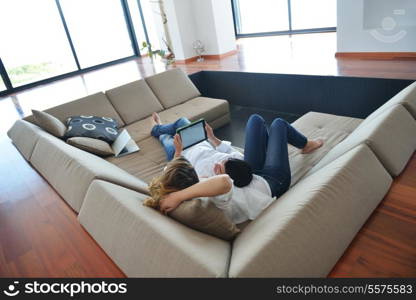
[244,114,269,173]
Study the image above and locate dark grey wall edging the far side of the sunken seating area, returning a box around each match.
[190,71,412,118]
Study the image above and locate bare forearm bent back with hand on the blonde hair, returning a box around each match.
[160,175,233,214]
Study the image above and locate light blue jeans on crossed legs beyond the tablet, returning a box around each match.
[150,118,191,161]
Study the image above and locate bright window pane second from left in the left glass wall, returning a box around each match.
[60,0,134,68]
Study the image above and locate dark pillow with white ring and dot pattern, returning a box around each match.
[64,116,118,145]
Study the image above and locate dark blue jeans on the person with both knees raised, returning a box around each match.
[244,114,308,197]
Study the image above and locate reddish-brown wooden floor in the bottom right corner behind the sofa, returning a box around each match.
[329,154,416,277]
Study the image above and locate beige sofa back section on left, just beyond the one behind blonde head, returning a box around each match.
[30,135,148,212]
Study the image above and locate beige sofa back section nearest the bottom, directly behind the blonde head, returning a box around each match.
[78,180,230,277]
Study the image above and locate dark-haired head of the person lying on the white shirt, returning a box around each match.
[214,158,253,187]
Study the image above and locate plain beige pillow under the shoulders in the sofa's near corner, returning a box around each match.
[169,199,240,241]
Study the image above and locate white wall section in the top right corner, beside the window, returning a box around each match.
[337,0,416,52]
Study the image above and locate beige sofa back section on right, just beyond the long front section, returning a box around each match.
[307,104,416,176]
